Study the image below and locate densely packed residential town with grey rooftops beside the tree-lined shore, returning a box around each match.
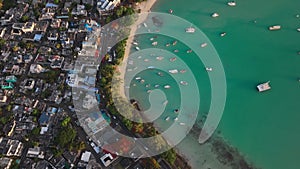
[0,0,183,169]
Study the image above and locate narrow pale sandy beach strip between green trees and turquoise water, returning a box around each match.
[118,0,156,98]
